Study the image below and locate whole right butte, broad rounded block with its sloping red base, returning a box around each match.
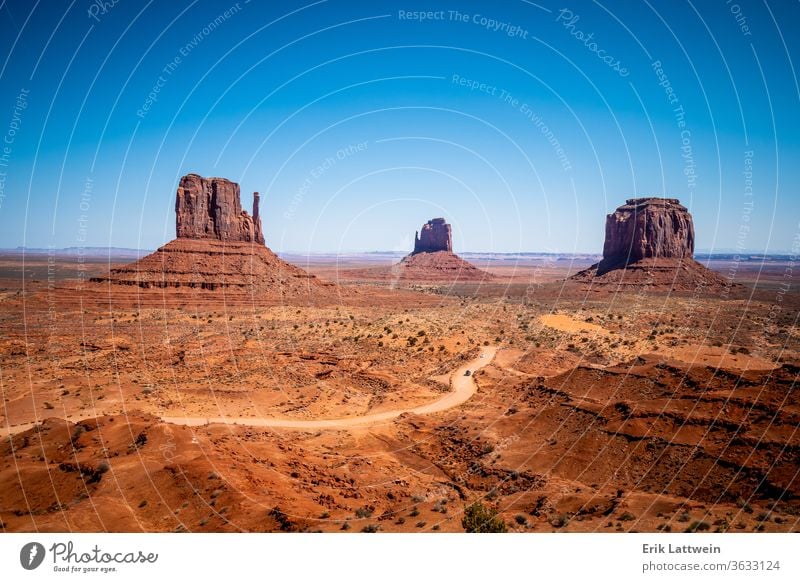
[571,197,726,290]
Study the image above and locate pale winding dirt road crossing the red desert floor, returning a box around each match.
[0,346,497,436]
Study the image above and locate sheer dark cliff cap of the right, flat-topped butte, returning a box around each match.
[603,198,694,263]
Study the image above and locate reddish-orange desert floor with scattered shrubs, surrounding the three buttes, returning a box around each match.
[0,253,800,532]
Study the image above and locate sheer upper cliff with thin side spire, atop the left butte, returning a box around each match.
[175,174,264,245]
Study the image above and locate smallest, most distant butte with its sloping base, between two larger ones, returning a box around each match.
[391,218,494,282]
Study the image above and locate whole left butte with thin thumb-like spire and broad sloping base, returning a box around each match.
[91,174,333,299]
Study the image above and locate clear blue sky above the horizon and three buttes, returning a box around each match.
[0,0,800,252]
